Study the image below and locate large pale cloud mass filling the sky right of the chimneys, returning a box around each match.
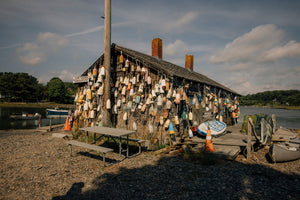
[209,24,300,94]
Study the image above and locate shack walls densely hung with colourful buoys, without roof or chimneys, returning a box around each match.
[75,52,239,143]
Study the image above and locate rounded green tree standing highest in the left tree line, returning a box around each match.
[47,77,66,103]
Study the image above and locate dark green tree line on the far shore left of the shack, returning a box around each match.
[0,72,77,104]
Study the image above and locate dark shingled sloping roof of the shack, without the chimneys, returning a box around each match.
[82,44,240,96]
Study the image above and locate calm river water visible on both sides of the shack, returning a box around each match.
[0,106,300,130]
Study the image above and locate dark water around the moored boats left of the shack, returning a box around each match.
[0,107,66,130]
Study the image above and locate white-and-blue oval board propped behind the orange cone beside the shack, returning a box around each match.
[197,121,226,136]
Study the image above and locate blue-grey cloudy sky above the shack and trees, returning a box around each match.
[0,0,300,95]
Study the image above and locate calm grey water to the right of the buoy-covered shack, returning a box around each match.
[239,106,300,129]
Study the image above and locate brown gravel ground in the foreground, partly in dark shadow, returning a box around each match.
[0,130,300,199]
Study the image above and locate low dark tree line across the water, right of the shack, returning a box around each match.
[240,90,300,106]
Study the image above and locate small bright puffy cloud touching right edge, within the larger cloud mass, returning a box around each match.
[259,41,300,62]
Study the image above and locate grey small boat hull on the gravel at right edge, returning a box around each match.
[269,142,300,162]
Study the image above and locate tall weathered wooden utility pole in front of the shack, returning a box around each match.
[103,0,111,126]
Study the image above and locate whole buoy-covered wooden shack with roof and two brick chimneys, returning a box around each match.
[73,38,240,143]
